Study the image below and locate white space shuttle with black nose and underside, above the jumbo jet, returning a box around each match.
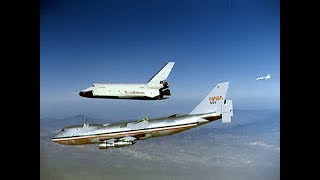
[79,62,175,100]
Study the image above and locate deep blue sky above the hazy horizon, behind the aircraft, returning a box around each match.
[40,0,280,118]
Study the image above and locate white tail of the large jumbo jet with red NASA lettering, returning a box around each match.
[190,82,233,123]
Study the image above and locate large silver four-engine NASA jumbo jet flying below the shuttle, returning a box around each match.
[52,82,233,149]
